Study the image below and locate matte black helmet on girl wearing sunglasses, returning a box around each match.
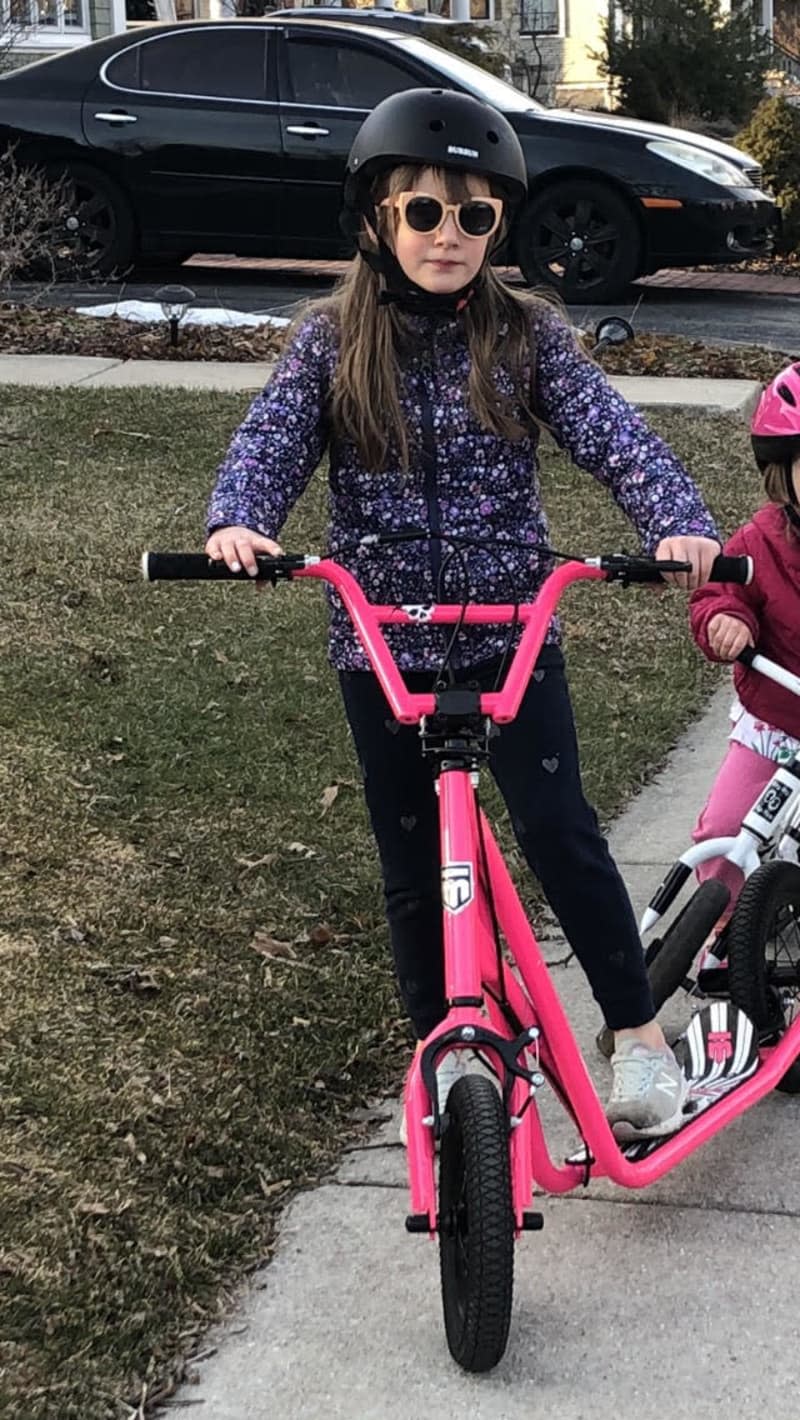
[344,88,527,216]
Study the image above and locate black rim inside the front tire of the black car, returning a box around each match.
[533,197,621,291]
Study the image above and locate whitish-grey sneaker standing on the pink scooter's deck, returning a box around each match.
[605,1039,689,1139]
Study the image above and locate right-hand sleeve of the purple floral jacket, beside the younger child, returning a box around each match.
[533,312,719,554]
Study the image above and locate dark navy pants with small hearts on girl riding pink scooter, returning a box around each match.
[340,646,655,1038]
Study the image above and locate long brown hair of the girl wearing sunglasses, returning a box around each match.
[298,165,553,473]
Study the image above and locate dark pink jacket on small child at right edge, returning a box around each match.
[689,503,800,738]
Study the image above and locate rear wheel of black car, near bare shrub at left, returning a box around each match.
[50,163,136,275]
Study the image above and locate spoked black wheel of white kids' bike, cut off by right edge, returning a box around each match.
[728,859,800,1095]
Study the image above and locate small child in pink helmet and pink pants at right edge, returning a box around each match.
[689,364,800,914]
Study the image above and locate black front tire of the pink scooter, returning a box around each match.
[439,1075,514,1372]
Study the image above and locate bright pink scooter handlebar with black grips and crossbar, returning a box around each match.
[142,552,753,724]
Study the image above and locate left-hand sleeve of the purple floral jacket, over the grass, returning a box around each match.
[207,315,333,538]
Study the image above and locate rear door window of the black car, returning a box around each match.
[107,27,267,99]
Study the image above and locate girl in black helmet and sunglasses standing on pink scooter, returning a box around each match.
[206,89,719,1133]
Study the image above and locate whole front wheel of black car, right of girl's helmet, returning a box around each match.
[516,178,642,304]
